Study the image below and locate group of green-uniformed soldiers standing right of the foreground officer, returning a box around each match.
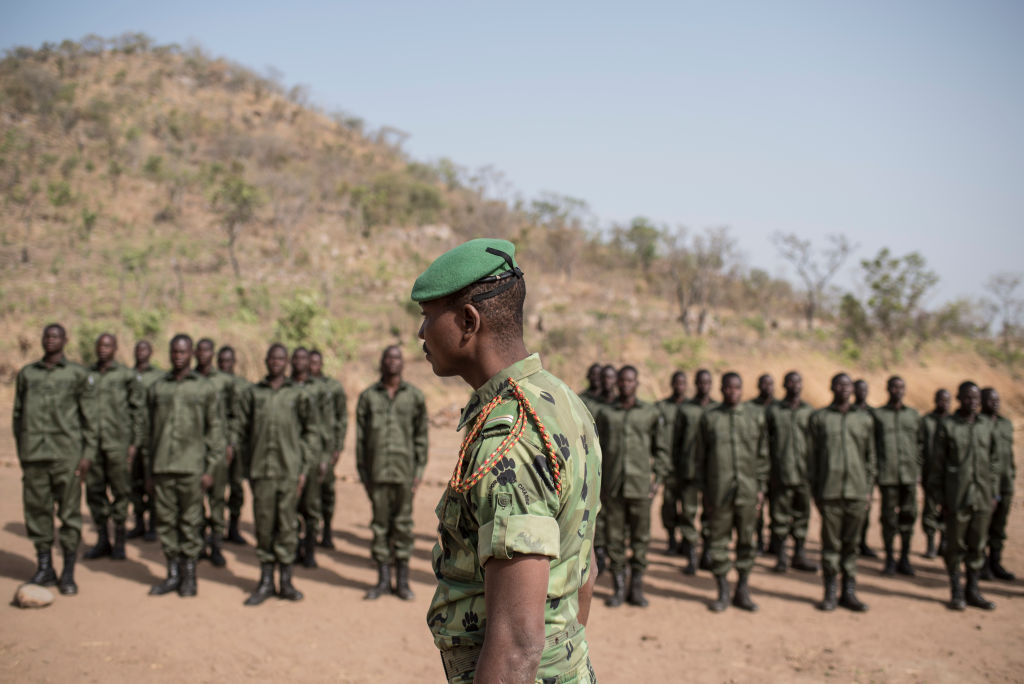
[580,364,1015,611]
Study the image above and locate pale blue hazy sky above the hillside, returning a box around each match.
[0,0,1024,303]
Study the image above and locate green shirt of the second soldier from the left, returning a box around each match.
[87,361,145,461]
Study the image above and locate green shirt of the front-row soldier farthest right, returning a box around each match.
[930,412,1000,512]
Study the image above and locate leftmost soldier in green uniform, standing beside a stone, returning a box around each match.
[11,323,96,595]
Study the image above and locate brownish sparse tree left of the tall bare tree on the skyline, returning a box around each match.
[662,226,736,335]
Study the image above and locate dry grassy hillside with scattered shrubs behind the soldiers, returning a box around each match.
[0,36,1024,422]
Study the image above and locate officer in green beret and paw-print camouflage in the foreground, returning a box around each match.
[412,240,601,683]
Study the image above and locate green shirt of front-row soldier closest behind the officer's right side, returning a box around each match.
[597,399,671,499]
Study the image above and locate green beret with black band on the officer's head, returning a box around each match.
[413,238,522,302]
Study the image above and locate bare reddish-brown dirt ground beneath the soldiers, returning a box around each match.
[0,426,1024,682]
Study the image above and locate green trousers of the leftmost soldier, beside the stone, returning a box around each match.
[22,461,82,552]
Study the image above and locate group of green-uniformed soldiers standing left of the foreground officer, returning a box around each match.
[12,324,428,605]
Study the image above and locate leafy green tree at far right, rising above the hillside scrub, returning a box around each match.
[860,248,939,358]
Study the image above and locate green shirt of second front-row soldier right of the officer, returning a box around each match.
[696,403,768,509]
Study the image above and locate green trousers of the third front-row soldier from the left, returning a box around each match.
[249,478,299,565]
